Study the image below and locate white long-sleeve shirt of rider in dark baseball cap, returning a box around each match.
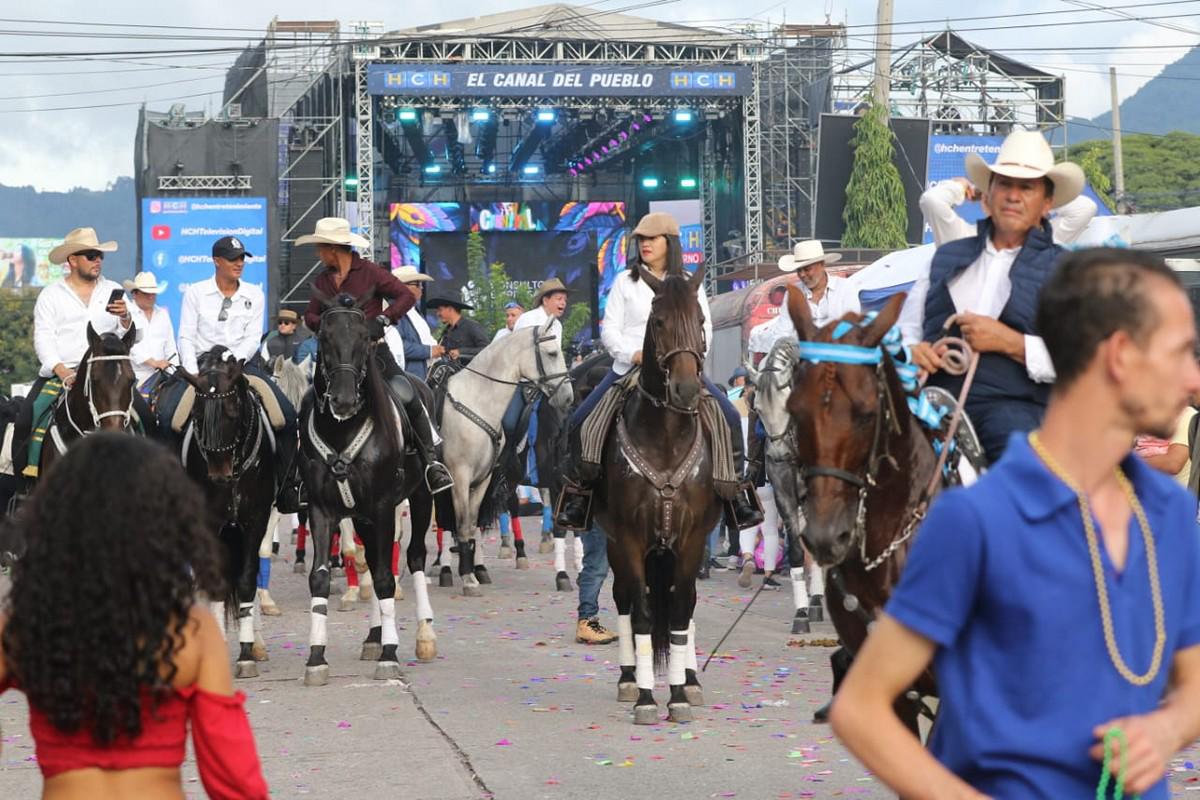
[179,277,266,372]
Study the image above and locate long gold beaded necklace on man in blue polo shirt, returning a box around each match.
[1030,431,1166,686]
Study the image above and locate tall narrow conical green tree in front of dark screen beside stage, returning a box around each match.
[841,103,908,249]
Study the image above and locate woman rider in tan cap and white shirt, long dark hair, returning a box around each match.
[554,212,762,530]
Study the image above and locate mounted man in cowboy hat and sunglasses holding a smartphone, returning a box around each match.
[13,228,132,477]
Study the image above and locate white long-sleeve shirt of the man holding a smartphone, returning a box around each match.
[34,278,128,378]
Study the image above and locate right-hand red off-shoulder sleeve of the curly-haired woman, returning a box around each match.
[181,688,270,800]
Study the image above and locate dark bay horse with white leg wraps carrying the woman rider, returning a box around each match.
[593,266,722,724]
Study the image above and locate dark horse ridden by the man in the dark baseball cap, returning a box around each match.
[175,345,275,678]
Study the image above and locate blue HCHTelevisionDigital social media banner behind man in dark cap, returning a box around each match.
[140,197,270,336]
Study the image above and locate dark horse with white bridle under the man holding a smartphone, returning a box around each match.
[37,323,139,475]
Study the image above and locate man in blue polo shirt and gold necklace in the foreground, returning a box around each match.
[832,248,1200,800]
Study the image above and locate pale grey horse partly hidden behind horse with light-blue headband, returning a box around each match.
[746,338,824,633]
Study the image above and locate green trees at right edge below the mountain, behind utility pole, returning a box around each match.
[1069,131,1200,212]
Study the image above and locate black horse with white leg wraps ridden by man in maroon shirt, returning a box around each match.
[299,291,437,686]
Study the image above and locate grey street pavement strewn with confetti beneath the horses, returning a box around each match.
[7,518,1200,800]
